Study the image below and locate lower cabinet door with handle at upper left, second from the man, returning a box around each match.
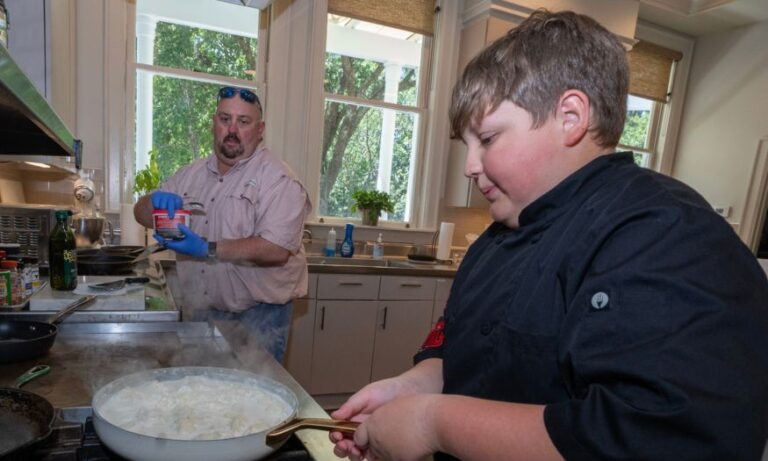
[309,300,377,394]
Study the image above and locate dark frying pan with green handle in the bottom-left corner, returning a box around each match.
[0,365,54,459]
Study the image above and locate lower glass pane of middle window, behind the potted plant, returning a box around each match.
[318,101,418,221]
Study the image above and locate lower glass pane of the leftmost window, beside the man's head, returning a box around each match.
[136,71,219,180]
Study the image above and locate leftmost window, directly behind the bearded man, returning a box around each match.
[135,0,261,180]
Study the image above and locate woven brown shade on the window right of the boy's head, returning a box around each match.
[627,41,683,102]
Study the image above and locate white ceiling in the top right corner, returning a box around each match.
[639,0,768,37]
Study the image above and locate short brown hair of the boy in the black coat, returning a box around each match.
[449,10,629,147]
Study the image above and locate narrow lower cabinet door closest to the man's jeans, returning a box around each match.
[285,298,315,389]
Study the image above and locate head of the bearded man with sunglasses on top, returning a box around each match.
[213,87,264,169]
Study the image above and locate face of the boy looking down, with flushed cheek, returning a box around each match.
[462,101,564,228]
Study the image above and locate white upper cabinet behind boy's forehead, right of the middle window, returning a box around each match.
[443,17,514,207]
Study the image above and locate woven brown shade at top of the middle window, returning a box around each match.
[328,0,435,36]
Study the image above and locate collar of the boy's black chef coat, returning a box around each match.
[520,152,635,227]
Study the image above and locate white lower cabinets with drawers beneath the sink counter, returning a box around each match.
[294,274,452,396]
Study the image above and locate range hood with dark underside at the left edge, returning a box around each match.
[0,45,82,170]
